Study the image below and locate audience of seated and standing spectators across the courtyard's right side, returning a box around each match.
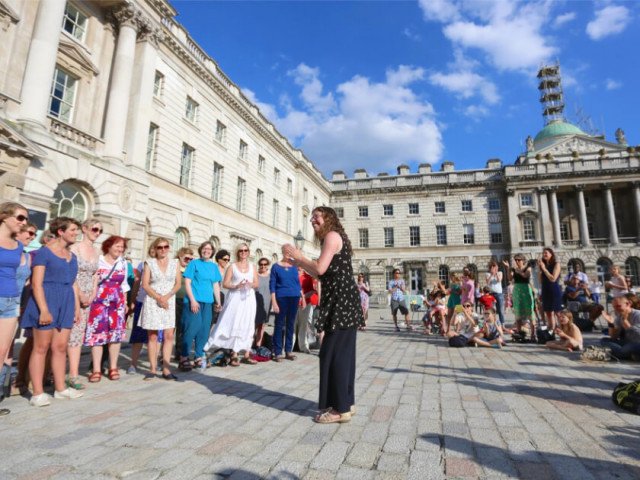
[384,248,640,360]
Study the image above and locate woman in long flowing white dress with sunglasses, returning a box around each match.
[204,243,258,367]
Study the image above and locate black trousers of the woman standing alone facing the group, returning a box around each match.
[318,328,357,413]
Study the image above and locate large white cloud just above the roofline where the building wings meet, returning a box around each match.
[251,64,443,174]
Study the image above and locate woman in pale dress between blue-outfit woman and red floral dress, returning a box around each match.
[67,218,103,390]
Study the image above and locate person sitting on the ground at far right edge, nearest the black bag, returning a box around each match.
[600,296,640,361]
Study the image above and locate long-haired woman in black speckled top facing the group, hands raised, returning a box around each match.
[283,207,364,423]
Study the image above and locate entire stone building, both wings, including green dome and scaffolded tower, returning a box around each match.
[0,0,640,292]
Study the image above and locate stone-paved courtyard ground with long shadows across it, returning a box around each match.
[0,310,640,480]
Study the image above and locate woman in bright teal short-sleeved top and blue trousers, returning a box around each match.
[180,242,222,371]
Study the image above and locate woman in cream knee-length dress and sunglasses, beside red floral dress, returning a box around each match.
[140,237,182,380]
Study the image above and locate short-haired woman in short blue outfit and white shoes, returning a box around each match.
[21,217,83,407]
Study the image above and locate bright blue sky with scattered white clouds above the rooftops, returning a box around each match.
[173,0,640,177]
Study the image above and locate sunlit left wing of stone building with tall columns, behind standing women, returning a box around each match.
[0,0,330,258]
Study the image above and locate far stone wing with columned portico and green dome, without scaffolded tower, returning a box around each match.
[331,120,640,292]
